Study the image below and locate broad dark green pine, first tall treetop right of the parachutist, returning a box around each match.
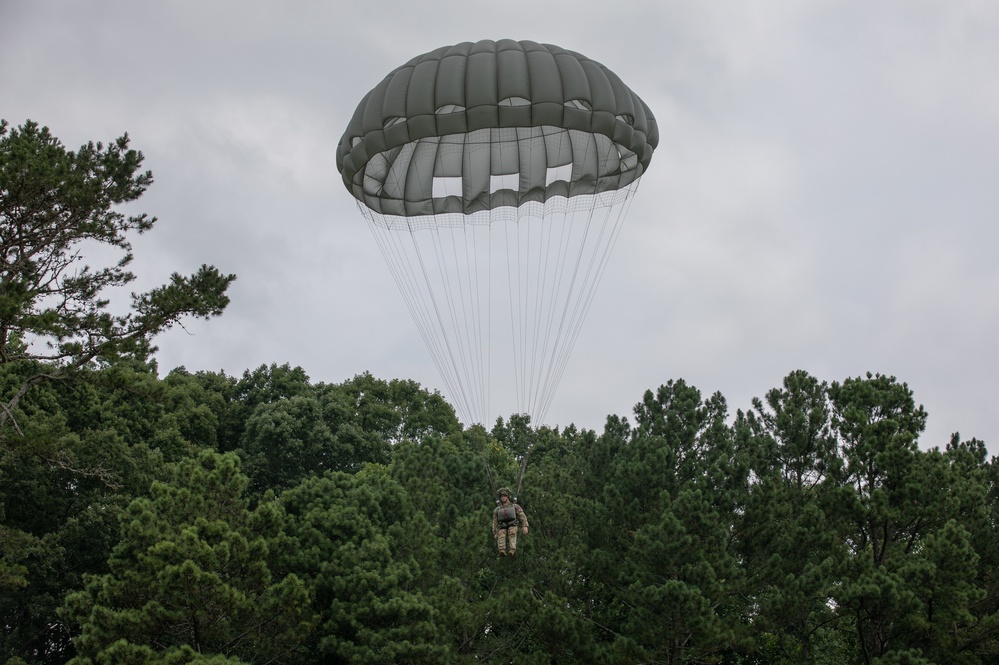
[585,381,747,663]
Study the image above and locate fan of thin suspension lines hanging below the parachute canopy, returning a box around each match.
[358,179,639,424]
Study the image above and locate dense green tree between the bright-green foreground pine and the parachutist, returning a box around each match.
[280,465,446,664]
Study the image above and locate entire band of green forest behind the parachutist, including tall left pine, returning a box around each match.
[0,123,999,665]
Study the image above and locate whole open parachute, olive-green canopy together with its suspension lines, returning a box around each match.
[337,40,659,423]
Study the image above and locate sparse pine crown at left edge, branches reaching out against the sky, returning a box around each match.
[0,120,235,428]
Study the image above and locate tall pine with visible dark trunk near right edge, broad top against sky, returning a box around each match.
[829,375,956,662]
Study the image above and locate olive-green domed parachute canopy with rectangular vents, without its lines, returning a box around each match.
[337,40,659,217]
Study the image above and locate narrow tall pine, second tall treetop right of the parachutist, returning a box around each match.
[735,371,842,663]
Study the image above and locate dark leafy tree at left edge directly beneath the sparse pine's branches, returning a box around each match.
[0,365,170,663]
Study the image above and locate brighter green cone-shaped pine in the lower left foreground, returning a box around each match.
[64,452,313,663]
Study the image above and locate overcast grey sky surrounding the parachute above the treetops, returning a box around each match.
[0,0,999,454]
